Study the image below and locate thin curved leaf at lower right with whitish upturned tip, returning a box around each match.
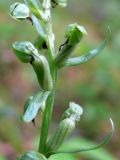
[51,119,114,154]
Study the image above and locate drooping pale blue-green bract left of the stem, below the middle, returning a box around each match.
[22,91,50,123]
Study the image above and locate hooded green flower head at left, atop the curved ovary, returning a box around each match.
[12,41,37,63]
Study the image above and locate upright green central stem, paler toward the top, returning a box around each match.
[38,0,56,154]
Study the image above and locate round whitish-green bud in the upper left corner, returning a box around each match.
[10,3,29,20]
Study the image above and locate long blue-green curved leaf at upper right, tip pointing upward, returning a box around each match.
[63,28,110,67]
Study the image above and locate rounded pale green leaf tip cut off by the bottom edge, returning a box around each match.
[17,151,47,160]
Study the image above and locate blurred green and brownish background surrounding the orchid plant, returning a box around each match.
[0,0,120,160]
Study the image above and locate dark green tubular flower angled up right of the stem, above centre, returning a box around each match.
[55,23,87,67]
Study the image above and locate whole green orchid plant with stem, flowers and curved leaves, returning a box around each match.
[10,0,114,160]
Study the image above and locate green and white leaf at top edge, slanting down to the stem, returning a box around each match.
[24,0,46,21]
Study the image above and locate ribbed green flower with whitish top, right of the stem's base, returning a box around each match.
[47,102,83,154]
